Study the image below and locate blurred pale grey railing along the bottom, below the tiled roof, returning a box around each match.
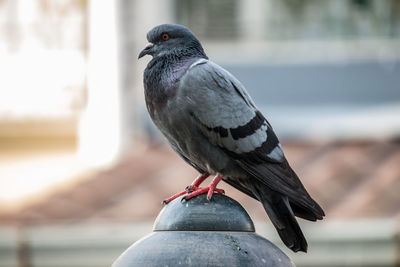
[0,219,400,267]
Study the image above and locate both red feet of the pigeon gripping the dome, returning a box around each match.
[162,173,225,204]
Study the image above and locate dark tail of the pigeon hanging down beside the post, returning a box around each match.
[255,188,307,252]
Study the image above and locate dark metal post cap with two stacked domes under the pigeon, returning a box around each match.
[113,194,294,267]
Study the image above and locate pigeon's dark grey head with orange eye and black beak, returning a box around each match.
[139,24,207,58]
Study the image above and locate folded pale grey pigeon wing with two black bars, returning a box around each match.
[180,60,320,214]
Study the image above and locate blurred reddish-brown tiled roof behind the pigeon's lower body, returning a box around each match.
[0,141,400,223]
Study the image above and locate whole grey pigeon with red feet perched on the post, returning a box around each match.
[138,24,325,252]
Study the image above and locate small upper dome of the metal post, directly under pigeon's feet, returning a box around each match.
[153,194,255,232]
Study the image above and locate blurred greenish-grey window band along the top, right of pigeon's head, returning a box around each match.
[175,0,400,40]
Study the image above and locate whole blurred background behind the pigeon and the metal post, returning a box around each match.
[0,0,400,267]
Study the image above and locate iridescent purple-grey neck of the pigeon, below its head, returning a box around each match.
[143,55,200,103]
